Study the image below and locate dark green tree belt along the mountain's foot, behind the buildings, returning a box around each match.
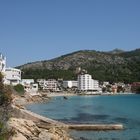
[22,63,140,83]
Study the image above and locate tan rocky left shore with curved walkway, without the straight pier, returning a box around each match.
[7,93,72,140]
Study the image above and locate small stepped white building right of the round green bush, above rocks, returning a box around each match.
[21,79,39,95]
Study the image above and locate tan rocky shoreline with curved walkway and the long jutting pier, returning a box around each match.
[7,94,123,140]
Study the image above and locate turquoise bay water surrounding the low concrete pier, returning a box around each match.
[27,94,140,140]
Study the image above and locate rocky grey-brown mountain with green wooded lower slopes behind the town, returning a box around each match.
[18,49,140,83]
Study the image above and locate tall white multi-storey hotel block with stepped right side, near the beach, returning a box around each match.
[78,74,100,91]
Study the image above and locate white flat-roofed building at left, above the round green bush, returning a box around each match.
[4,68,21,85]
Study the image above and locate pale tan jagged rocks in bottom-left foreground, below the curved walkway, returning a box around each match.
[7,118,71,140]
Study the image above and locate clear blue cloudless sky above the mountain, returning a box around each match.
[0,0,140,67]
